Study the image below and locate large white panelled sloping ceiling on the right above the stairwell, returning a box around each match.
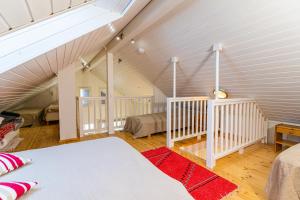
[118,0,300,123]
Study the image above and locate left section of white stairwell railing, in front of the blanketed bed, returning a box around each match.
[167,97,209,147]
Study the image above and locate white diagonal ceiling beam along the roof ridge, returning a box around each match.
[88,0,184,68]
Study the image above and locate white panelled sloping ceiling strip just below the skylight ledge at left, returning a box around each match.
[0,0,149,110]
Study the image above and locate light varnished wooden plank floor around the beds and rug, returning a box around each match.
[16,125,277,200]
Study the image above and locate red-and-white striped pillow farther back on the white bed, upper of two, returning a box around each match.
[0,153,31,176]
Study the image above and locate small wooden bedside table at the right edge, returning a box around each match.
[275,124,300,152]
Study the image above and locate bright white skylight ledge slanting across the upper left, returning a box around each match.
[0,1,124,73]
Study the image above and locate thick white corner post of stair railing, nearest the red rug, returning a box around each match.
[206,100,216,169]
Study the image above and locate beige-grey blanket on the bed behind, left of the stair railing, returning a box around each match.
[124,112,167,138]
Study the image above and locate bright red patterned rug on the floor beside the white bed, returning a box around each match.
[142,147,237,200]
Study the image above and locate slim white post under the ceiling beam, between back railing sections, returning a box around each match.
[106,52,115,134]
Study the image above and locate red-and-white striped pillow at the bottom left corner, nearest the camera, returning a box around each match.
[0,181,37,200]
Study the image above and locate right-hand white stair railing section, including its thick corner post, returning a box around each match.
[206,99,267,168]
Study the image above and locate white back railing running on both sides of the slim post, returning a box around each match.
[78,96,153,136]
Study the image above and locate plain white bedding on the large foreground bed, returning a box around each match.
[1,137,193,200]
